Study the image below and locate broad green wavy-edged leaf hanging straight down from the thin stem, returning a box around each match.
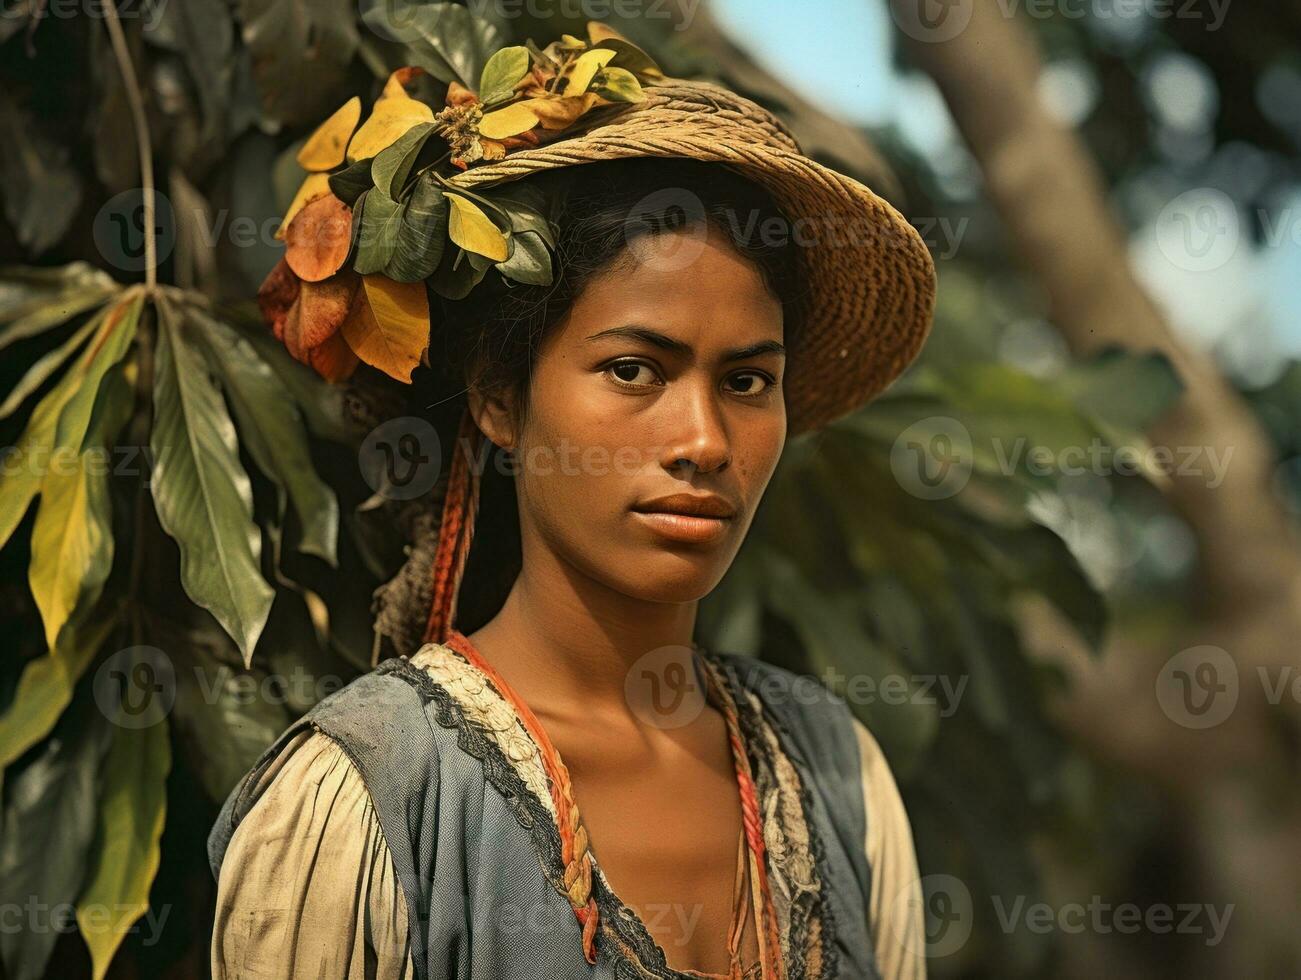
[150,299,273,660]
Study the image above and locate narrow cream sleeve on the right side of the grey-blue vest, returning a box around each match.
[853,720,926,980]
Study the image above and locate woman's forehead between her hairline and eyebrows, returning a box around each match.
[557,225,782,350]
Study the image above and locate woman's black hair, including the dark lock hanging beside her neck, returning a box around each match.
[411,157,804,633]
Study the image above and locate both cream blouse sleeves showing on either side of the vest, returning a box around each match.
[212,702,926,980]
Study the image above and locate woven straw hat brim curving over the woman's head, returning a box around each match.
[453,79,935,435]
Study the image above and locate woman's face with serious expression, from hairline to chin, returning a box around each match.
[488,225,786,603]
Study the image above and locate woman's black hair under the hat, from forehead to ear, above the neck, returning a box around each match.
[429,157,801,413]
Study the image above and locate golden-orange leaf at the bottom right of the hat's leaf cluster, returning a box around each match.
[351,275,429,384]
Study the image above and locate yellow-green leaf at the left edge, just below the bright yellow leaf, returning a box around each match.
[0,609,120,769]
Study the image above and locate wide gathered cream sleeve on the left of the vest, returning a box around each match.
[212,731,414,980]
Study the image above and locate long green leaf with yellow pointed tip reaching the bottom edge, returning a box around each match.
[77,717,172,980]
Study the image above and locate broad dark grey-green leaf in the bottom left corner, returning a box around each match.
[0,692,111,980]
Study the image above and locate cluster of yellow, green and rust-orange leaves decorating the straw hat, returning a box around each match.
[259,19,664,383]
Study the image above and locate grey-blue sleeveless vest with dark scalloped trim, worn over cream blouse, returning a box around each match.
[208,655,879,980]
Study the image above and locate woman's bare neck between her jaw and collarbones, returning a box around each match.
[471,536,697,716]
